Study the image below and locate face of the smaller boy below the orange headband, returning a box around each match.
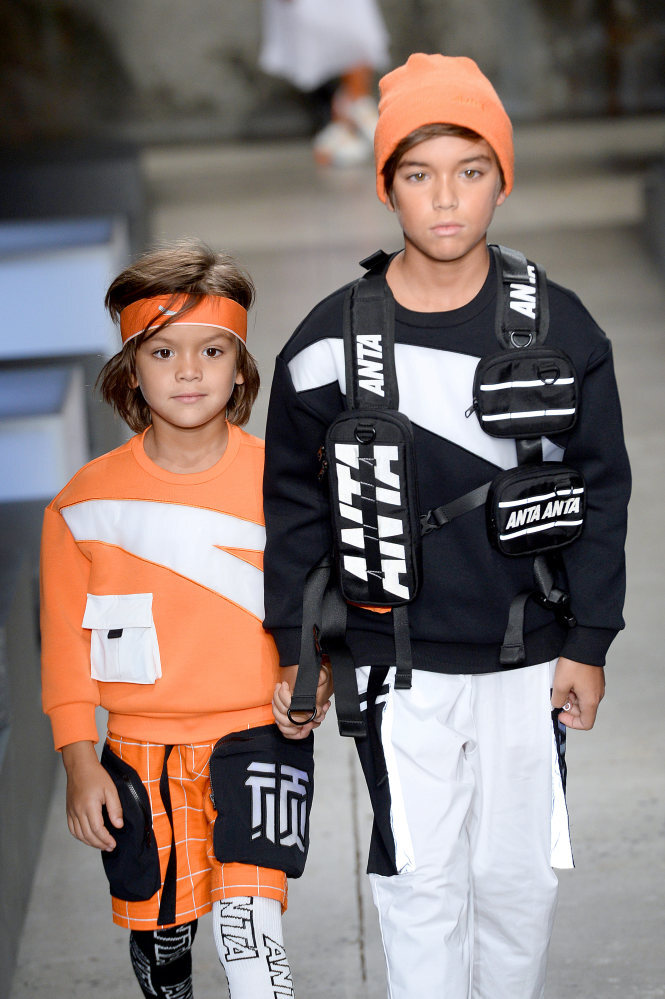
[132,324,244,430]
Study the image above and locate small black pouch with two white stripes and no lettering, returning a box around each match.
[473,347,578,438]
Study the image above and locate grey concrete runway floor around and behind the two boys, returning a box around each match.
[11,118,665,999]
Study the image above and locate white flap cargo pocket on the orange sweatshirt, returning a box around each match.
[83,593,162,683]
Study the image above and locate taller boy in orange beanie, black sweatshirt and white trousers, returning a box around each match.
[264,54,629,999]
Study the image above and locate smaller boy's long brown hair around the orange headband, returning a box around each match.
[97,239,260,433]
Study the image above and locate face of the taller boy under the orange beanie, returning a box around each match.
[388,135,506,261]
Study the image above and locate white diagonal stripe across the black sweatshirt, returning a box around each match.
[289,337,563,468]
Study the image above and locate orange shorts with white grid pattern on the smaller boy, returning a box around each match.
[107,732,287,930]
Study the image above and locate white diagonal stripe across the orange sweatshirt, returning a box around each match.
[61,499,265,621]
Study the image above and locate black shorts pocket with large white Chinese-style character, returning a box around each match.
[210,725,314,878]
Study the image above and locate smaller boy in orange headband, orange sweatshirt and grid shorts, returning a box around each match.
[41,241,312,999]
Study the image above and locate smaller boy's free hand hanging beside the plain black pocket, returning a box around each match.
[62,742,123,853]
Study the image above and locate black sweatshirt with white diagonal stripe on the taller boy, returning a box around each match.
[264,250,630,673]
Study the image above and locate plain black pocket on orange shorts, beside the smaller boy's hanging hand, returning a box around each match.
[100,743,162,902]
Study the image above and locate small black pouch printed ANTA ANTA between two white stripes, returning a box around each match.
[486,461,586,555]
